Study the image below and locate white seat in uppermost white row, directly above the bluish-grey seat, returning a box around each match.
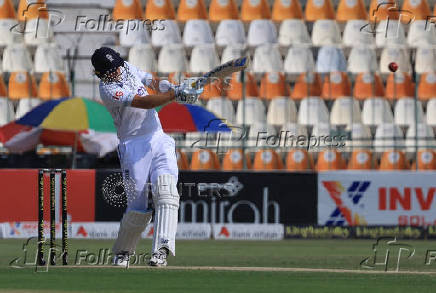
[312,19,341,46]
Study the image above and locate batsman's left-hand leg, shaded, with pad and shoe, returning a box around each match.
[112,140,152,266]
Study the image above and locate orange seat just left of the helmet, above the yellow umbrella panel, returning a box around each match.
[38,72,71,100]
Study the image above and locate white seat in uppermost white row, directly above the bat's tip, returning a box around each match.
[215,19,246,47]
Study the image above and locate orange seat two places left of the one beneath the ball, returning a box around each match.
[321,72,351,99]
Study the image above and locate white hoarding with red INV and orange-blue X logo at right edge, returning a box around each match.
[318,171,436,226]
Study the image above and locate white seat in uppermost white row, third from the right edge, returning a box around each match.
[342,19,375,47]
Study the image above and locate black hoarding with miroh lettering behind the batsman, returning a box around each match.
[95,170,317,225]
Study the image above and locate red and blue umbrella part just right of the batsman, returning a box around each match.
[156,102,231,132]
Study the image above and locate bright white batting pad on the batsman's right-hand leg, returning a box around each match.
[152,174,180,255]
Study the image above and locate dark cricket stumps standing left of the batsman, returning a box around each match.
[37,169,68,265]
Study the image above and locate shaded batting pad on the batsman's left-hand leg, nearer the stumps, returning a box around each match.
[112,210,152,255]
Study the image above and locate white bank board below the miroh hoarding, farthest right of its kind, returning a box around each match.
[212,224,283,240]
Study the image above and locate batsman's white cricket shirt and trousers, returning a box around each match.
[100,62,178,211]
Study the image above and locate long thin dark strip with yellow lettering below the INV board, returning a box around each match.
[285,226,424,239]
